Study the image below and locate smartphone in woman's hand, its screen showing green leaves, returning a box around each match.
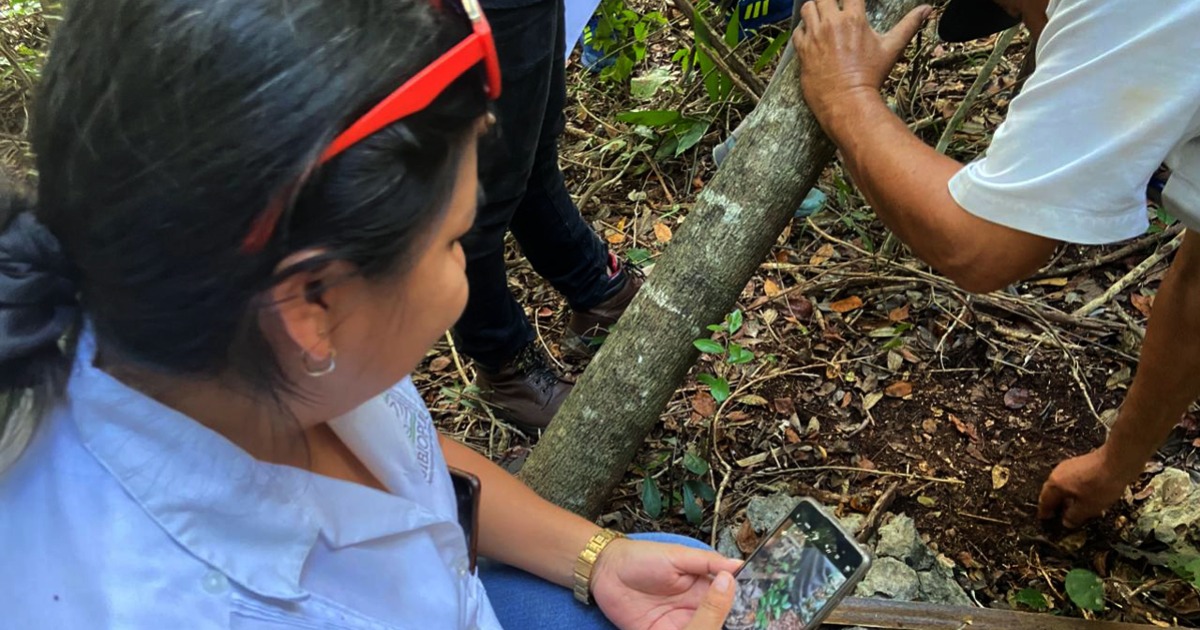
[725,499,871,630]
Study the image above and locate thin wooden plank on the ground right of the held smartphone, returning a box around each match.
[826,598,1185,630]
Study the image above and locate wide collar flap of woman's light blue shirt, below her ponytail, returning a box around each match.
[67,331,320,600]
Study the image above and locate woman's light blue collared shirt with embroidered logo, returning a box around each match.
[0,335,499,630]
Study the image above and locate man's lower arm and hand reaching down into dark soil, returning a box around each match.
[1038,232,1200,527]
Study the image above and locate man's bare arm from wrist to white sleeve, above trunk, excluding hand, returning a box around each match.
[822,92,1055,292]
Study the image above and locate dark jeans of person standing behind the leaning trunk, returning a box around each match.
[454,0,610,370]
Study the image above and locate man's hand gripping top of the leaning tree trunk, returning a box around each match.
[792,0,932,125]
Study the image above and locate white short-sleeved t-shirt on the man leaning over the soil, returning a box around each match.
[949,0,1200,244]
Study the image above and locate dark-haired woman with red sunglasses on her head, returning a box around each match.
[0,0,737,630]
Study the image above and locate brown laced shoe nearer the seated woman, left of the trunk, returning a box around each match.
[475,341,575,436]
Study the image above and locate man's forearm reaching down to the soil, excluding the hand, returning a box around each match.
[1102,232,1200,480]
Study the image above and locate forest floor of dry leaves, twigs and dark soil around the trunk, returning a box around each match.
[0,0,1200,625]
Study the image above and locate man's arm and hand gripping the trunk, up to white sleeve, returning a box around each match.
[792,0,1056,293]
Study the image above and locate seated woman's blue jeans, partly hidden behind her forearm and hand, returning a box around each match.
[479,533,712,630]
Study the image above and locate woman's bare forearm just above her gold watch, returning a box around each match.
[440,436,600,588]
